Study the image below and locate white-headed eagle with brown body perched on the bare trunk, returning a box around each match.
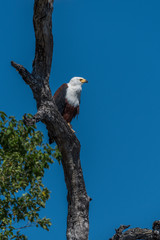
[53,77,88,132]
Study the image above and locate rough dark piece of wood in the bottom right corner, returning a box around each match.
[109,221,160,240]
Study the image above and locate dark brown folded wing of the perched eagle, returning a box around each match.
[53,83,68,115]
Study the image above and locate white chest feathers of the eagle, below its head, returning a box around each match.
[66,84,82,107]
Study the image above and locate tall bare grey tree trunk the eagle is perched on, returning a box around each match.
[11,0,90,240]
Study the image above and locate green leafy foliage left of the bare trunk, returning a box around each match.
[0,112,53,240]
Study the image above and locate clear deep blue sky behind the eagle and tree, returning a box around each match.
[0,0,160,240]
